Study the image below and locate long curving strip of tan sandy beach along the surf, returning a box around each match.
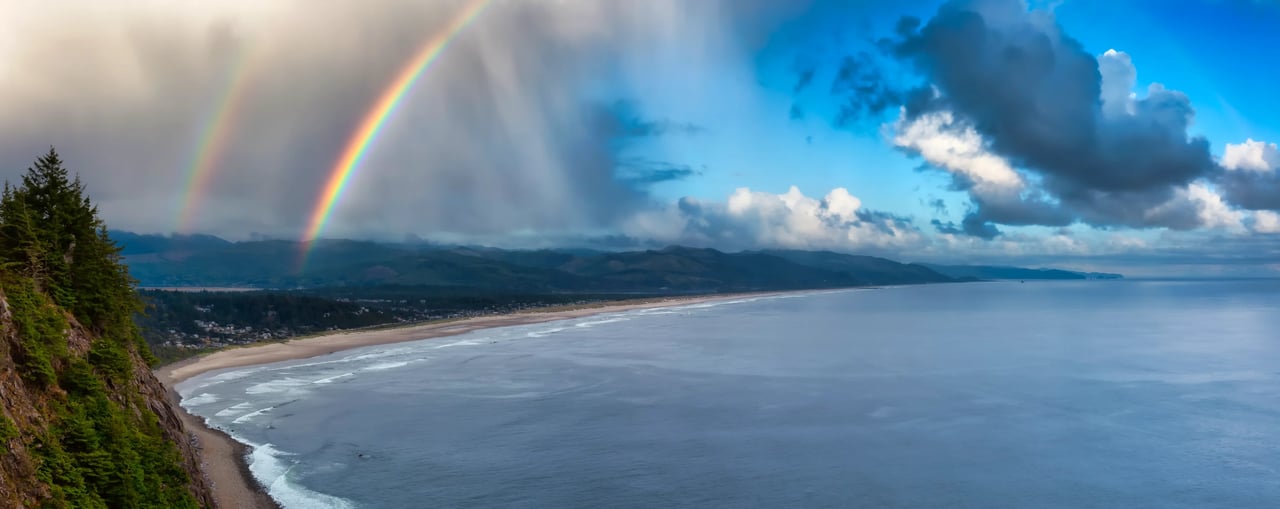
[154,290,793,509]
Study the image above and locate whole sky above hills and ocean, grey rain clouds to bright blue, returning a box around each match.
[0,0,1280,276]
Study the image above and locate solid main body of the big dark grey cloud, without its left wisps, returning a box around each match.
[893,0,1216,226]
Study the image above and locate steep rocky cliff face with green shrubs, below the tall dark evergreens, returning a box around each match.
[0,282,214,508]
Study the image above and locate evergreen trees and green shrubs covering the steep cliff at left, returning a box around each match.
[0,150,197,508]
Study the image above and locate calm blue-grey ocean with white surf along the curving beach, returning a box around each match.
[179,281,1280,509]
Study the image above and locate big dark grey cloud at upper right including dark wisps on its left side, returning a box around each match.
[798,0,1220,237]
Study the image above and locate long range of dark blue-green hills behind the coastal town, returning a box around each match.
[113,233,959,293]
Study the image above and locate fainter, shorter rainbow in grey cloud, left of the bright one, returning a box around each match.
[175,47,250,233]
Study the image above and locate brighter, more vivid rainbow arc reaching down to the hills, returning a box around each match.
[300,0,492,269]
